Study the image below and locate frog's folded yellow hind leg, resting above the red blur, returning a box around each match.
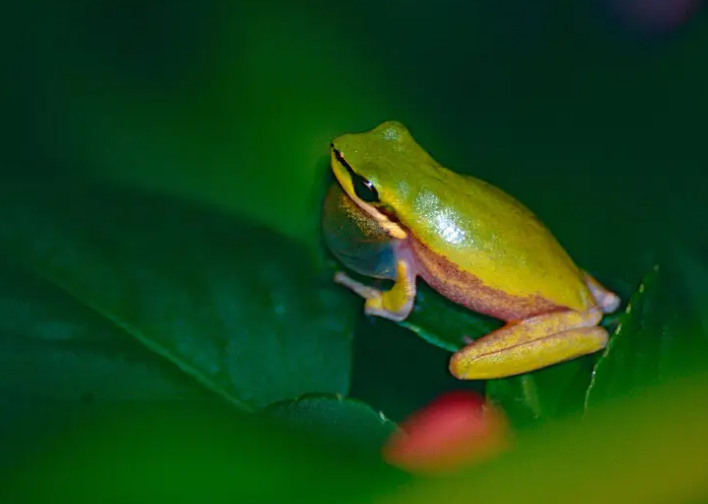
[450,308,608,380]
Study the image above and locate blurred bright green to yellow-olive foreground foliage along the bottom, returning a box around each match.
[0,375,708,504]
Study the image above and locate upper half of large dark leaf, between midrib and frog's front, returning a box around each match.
[0,182,355,411]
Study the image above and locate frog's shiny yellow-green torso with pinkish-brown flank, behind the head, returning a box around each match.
[402,166,593,319]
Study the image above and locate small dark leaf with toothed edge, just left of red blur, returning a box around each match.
[265,395,397,454]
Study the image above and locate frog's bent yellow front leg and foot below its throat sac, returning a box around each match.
[334,260,416,322]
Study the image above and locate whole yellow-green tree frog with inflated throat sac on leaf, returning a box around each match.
[323,121,620,379]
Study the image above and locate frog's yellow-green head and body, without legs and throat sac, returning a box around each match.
[332,121,596,321]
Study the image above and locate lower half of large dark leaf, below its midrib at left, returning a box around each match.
[0,254,209,404]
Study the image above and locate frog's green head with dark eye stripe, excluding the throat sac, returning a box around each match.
[330,121,432,239]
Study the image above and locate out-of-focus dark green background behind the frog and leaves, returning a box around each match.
[0,0,708,430]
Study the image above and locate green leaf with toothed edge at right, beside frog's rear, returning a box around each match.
[585,261,708,408]
